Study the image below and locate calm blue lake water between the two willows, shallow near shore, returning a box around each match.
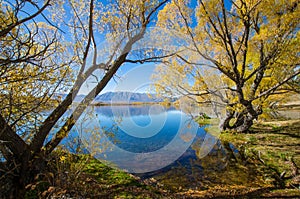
[66,105,234,187]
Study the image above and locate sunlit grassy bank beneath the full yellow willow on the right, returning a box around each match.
[216,120,300,198]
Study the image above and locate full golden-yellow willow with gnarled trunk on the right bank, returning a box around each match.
[156,0,300,132]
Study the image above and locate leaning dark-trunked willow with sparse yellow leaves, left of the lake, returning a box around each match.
[0,0,166,198]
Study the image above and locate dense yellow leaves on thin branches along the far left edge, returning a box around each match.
[0,0,72,141]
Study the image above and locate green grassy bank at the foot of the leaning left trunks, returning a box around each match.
[25,150,171,199]
